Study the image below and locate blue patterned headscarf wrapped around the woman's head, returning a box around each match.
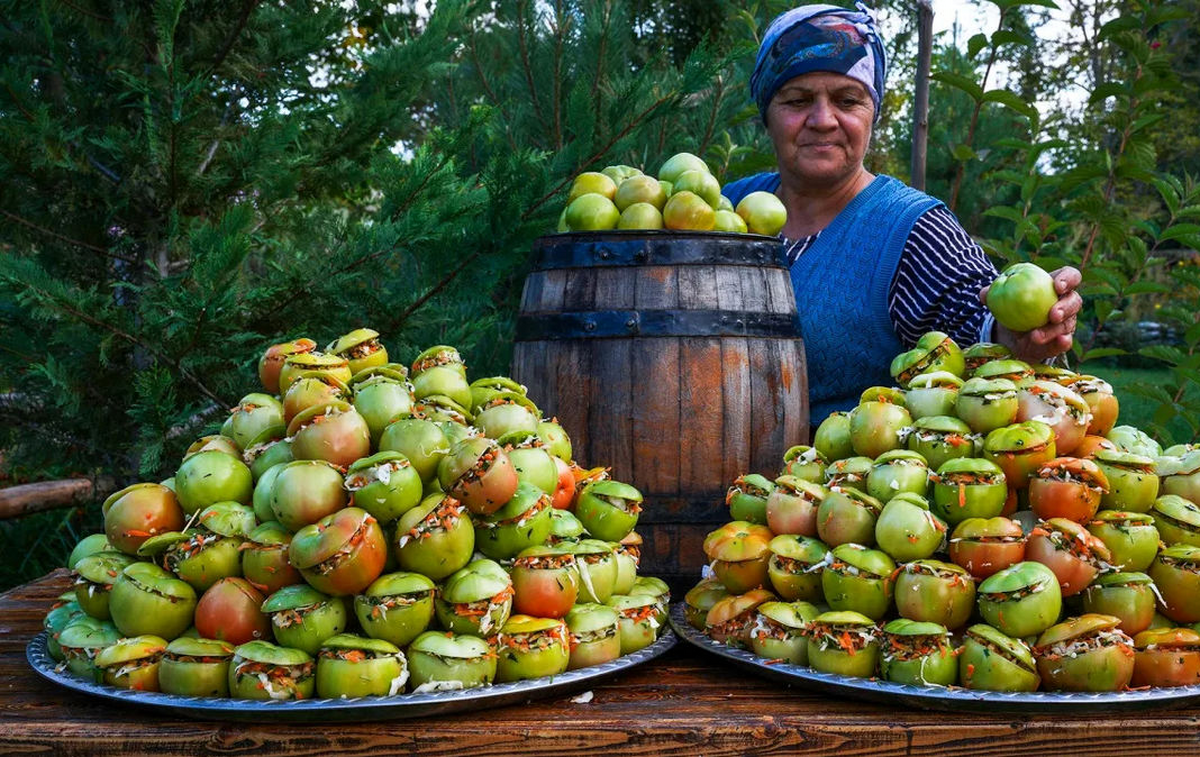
[750,1,887,121]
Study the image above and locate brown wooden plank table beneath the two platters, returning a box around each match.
[7,570,1200,757]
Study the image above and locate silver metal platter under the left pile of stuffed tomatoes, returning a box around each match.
[25,630,677,722]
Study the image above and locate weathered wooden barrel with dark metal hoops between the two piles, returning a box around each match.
[512,232,809,582]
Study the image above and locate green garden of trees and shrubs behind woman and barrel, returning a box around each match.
[0,0,1200,588]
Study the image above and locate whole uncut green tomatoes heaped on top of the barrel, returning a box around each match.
[557,152,787,236]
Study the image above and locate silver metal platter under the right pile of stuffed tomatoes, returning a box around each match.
[671,602,1200,715]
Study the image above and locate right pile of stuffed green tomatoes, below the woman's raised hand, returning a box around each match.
[685,328,1200,691]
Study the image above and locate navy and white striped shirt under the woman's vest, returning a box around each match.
[784,205,996,347]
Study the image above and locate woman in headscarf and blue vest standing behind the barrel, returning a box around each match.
[724,4,1082,422]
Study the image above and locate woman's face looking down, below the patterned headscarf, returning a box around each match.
[767,72,875,190]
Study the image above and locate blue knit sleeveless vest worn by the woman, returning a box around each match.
[722,173,942,425]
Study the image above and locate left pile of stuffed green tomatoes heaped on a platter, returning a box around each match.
[44,329,670,699]
